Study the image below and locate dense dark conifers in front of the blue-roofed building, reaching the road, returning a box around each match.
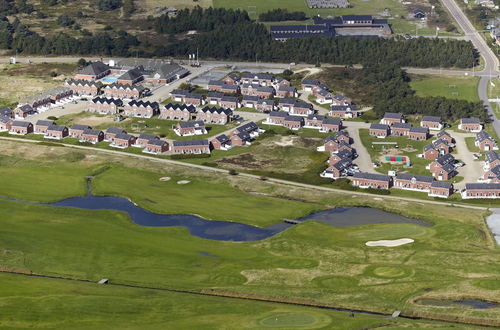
[154,8,479,68]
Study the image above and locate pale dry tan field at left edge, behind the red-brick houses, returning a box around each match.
[0,63,76,107]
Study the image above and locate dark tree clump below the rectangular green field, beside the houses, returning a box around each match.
[357,64,489,122]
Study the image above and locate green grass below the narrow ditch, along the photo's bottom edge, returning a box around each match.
[0,274,472,329]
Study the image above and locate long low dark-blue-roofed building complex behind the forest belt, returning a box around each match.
[270,15,392,41]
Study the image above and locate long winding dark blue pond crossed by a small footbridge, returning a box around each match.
[47,195,429,242]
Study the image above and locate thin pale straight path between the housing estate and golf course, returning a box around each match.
[0,136,488,210]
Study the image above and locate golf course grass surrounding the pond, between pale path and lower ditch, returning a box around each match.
[0,142,500,324]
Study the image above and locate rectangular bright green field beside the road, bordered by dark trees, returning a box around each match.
[410,74,479,102]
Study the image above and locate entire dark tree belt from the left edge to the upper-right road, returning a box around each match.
[0,5,478,68]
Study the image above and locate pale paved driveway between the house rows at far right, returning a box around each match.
[448,131,483,189]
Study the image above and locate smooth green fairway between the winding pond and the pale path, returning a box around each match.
[93,167,321,227]
